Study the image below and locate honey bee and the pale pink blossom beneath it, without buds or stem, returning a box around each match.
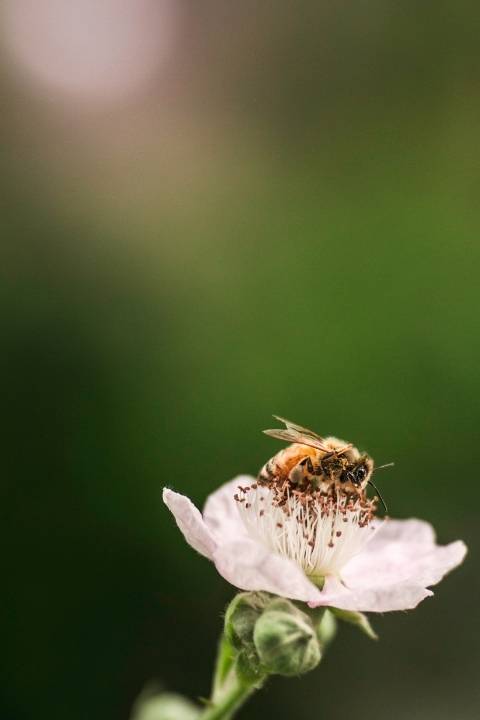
[163,418,466,612]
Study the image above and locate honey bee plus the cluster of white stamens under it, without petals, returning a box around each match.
[234,415,388,586]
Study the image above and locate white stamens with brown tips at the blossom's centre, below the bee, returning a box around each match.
[235,480,377,585]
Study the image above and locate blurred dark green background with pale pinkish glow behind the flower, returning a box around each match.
[0,0,480,720]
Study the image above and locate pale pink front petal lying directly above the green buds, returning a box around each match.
[213,537,321,602]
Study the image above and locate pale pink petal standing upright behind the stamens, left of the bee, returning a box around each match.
[203,475,251,542]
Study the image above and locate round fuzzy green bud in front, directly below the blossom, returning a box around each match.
[253,598,321,676]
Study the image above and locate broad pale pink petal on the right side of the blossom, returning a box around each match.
[310,519,467,612]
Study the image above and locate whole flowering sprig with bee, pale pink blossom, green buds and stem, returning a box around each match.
[159,416,467,720]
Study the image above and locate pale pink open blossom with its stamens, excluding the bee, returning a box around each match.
[163,476,466,612]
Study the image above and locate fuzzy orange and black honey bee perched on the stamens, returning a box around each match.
[258,415,387,510]
